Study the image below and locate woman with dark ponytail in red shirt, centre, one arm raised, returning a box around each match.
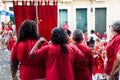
[30,28,84,80]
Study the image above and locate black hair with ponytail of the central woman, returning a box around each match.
[51,27,68,53]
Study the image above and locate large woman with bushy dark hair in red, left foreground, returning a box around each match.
[11,20,47,80]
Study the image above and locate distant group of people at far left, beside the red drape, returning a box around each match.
[0,22,16,51]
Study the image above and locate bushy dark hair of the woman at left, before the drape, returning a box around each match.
[17,20,40,43]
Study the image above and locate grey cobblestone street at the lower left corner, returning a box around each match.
[0,49,11,80]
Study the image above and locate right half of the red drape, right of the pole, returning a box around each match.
[38,5,57,40]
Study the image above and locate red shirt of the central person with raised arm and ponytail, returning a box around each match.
[34,44,84,80]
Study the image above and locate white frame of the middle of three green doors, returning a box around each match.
[74,6,90,31]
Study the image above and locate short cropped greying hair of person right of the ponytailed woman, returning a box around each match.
[73,29,83,42]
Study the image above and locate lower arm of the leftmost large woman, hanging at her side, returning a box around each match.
[11,60,19,80]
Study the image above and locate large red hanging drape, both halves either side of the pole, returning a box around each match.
[13,2,57,40]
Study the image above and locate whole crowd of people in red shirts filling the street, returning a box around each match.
[1,20,120,80]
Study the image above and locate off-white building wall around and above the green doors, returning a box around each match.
[58,0,120,36]
